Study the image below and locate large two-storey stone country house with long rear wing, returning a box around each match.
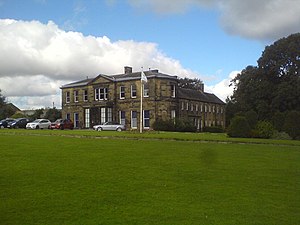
[61,66,225,131]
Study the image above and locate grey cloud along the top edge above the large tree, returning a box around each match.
[128,0,300,41]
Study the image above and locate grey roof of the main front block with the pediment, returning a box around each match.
[61,70,177,88]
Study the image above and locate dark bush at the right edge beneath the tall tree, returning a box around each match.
[283,111,300,140]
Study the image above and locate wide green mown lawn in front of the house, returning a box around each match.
[0,130,300,225]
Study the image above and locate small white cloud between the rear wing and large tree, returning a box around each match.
[205,71,241,101]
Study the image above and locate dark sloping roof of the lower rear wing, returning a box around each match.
[178,88,225,104]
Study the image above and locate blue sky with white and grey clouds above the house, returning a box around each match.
[0,0,300,109]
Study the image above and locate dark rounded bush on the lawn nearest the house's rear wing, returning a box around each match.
[227,116,251,137]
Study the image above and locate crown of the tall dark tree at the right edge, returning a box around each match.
[227,33,300,121]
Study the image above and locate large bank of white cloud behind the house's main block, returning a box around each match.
[0,19,199,108]
